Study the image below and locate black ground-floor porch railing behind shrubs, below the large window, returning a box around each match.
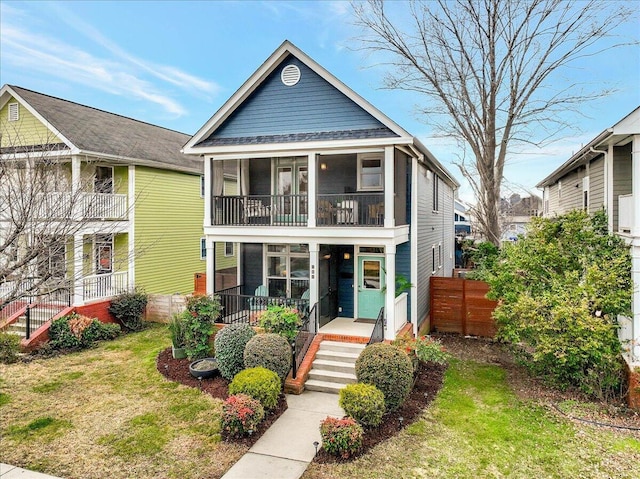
[215,285,309,325]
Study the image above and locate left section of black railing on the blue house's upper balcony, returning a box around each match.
[211,195,309,226]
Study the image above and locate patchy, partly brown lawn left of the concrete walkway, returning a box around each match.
[0,326,246,479]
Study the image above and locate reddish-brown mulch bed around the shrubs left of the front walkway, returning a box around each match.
[156,348,286,447]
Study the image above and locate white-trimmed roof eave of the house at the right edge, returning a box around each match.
[536,106,640,188]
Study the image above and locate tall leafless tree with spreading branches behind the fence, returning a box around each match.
[353,0,631,244]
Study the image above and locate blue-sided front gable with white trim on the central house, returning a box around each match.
[182,40,460,187]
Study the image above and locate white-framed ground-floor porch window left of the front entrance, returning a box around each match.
[265,244,309,298]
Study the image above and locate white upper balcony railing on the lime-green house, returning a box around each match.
[36,191,127,220]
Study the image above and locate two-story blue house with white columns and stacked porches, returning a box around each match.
[183,41,458,339]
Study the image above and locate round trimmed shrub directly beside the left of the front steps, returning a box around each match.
[244,333,291,382]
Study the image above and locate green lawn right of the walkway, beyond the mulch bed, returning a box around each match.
[303,360,640,479]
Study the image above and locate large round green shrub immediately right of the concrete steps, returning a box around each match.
[356,343,413,411]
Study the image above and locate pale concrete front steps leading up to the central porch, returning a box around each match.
[304,341,365,394]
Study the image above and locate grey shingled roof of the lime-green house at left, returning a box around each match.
[0,85,202,173]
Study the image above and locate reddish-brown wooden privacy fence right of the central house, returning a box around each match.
[430,276,497,338]
